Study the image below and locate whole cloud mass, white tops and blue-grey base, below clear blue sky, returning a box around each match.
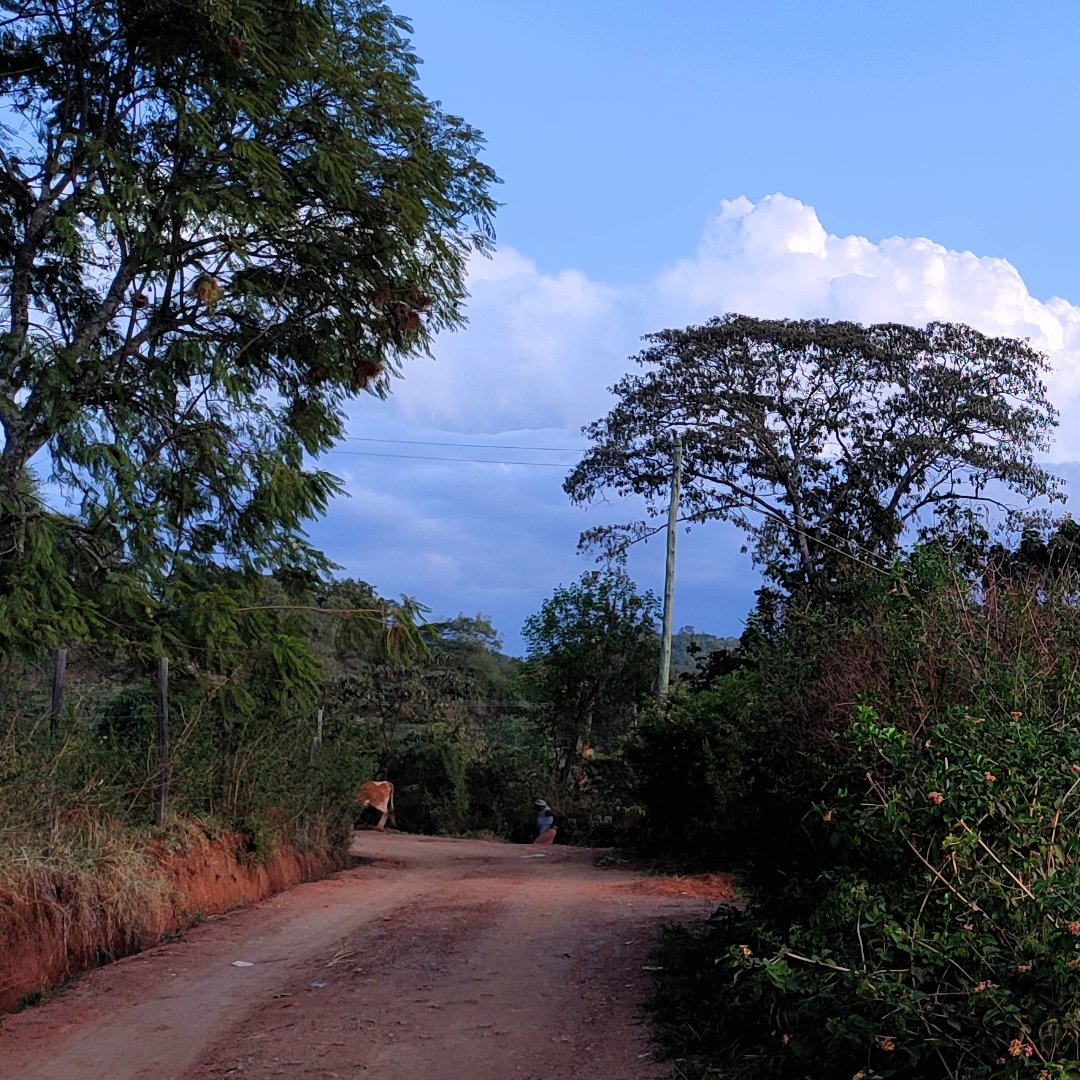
[324,194,1080,652]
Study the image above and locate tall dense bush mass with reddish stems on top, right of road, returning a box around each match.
[656,540,1080,1080]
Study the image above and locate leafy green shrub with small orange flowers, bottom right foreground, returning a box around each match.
[664,708,1080,1080]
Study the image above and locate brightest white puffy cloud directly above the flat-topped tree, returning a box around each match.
[650,194,1080,457]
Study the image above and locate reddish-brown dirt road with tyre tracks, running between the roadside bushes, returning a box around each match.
[0,832,725,1080]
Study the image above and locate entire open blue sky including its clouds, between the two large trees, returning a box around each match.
[311,0,1080,654]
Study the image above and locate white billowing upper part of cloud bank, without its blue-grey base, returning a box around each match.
[375,193,1080,457]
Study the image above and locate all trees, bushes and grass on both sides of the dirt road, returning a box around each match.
[0,0,1080,1080]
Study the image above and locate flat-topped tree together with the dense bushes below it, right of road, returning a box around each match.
[566,315,1080,1080]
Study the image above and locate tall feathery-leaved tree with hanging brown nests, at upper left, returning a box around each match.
[0,0,495,578]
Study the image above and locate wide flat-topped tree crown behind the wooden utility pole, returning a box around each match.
[565,314,1057,584]
